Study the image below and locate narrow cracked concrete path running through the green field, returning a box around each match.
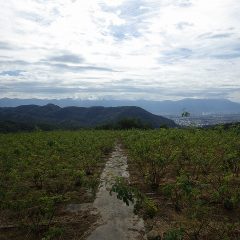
[87,145,146,240]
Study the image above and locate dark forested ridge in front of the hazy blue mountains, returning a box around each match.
[0,104,176,128]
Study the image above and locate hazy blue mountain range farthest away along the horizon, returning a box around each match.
[0,98,240,115]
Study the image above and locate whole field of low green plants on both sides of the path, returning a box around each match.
[0,128,240,240]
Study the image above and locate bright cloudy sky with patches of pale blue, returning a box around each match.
[0,0,240,102]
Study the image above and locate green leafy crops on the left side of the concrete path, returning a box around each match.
[0,131,115,240]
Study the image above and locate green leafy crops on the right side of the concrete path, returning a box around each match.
[122,129,240,240]
